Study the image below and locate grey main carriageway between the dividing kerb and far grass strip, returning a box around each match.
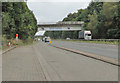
[52,41,118,60]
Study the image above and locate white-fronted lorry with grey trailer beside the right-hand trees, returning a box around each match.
[79,31,92,40]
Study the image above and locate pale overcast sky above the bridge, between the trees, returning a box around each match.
[27,0,91,23]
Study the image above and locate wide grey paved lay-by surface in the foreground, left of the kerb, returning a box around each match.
[2,42,118,81]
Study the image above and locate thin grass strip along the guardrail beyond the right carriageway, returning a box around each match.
[53,39,120,45]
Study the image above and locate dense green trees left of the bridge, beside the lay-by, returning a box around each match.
[2,2,37,40]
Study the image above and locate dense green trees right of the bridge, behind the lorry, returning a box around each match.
[63,2,120,38]
